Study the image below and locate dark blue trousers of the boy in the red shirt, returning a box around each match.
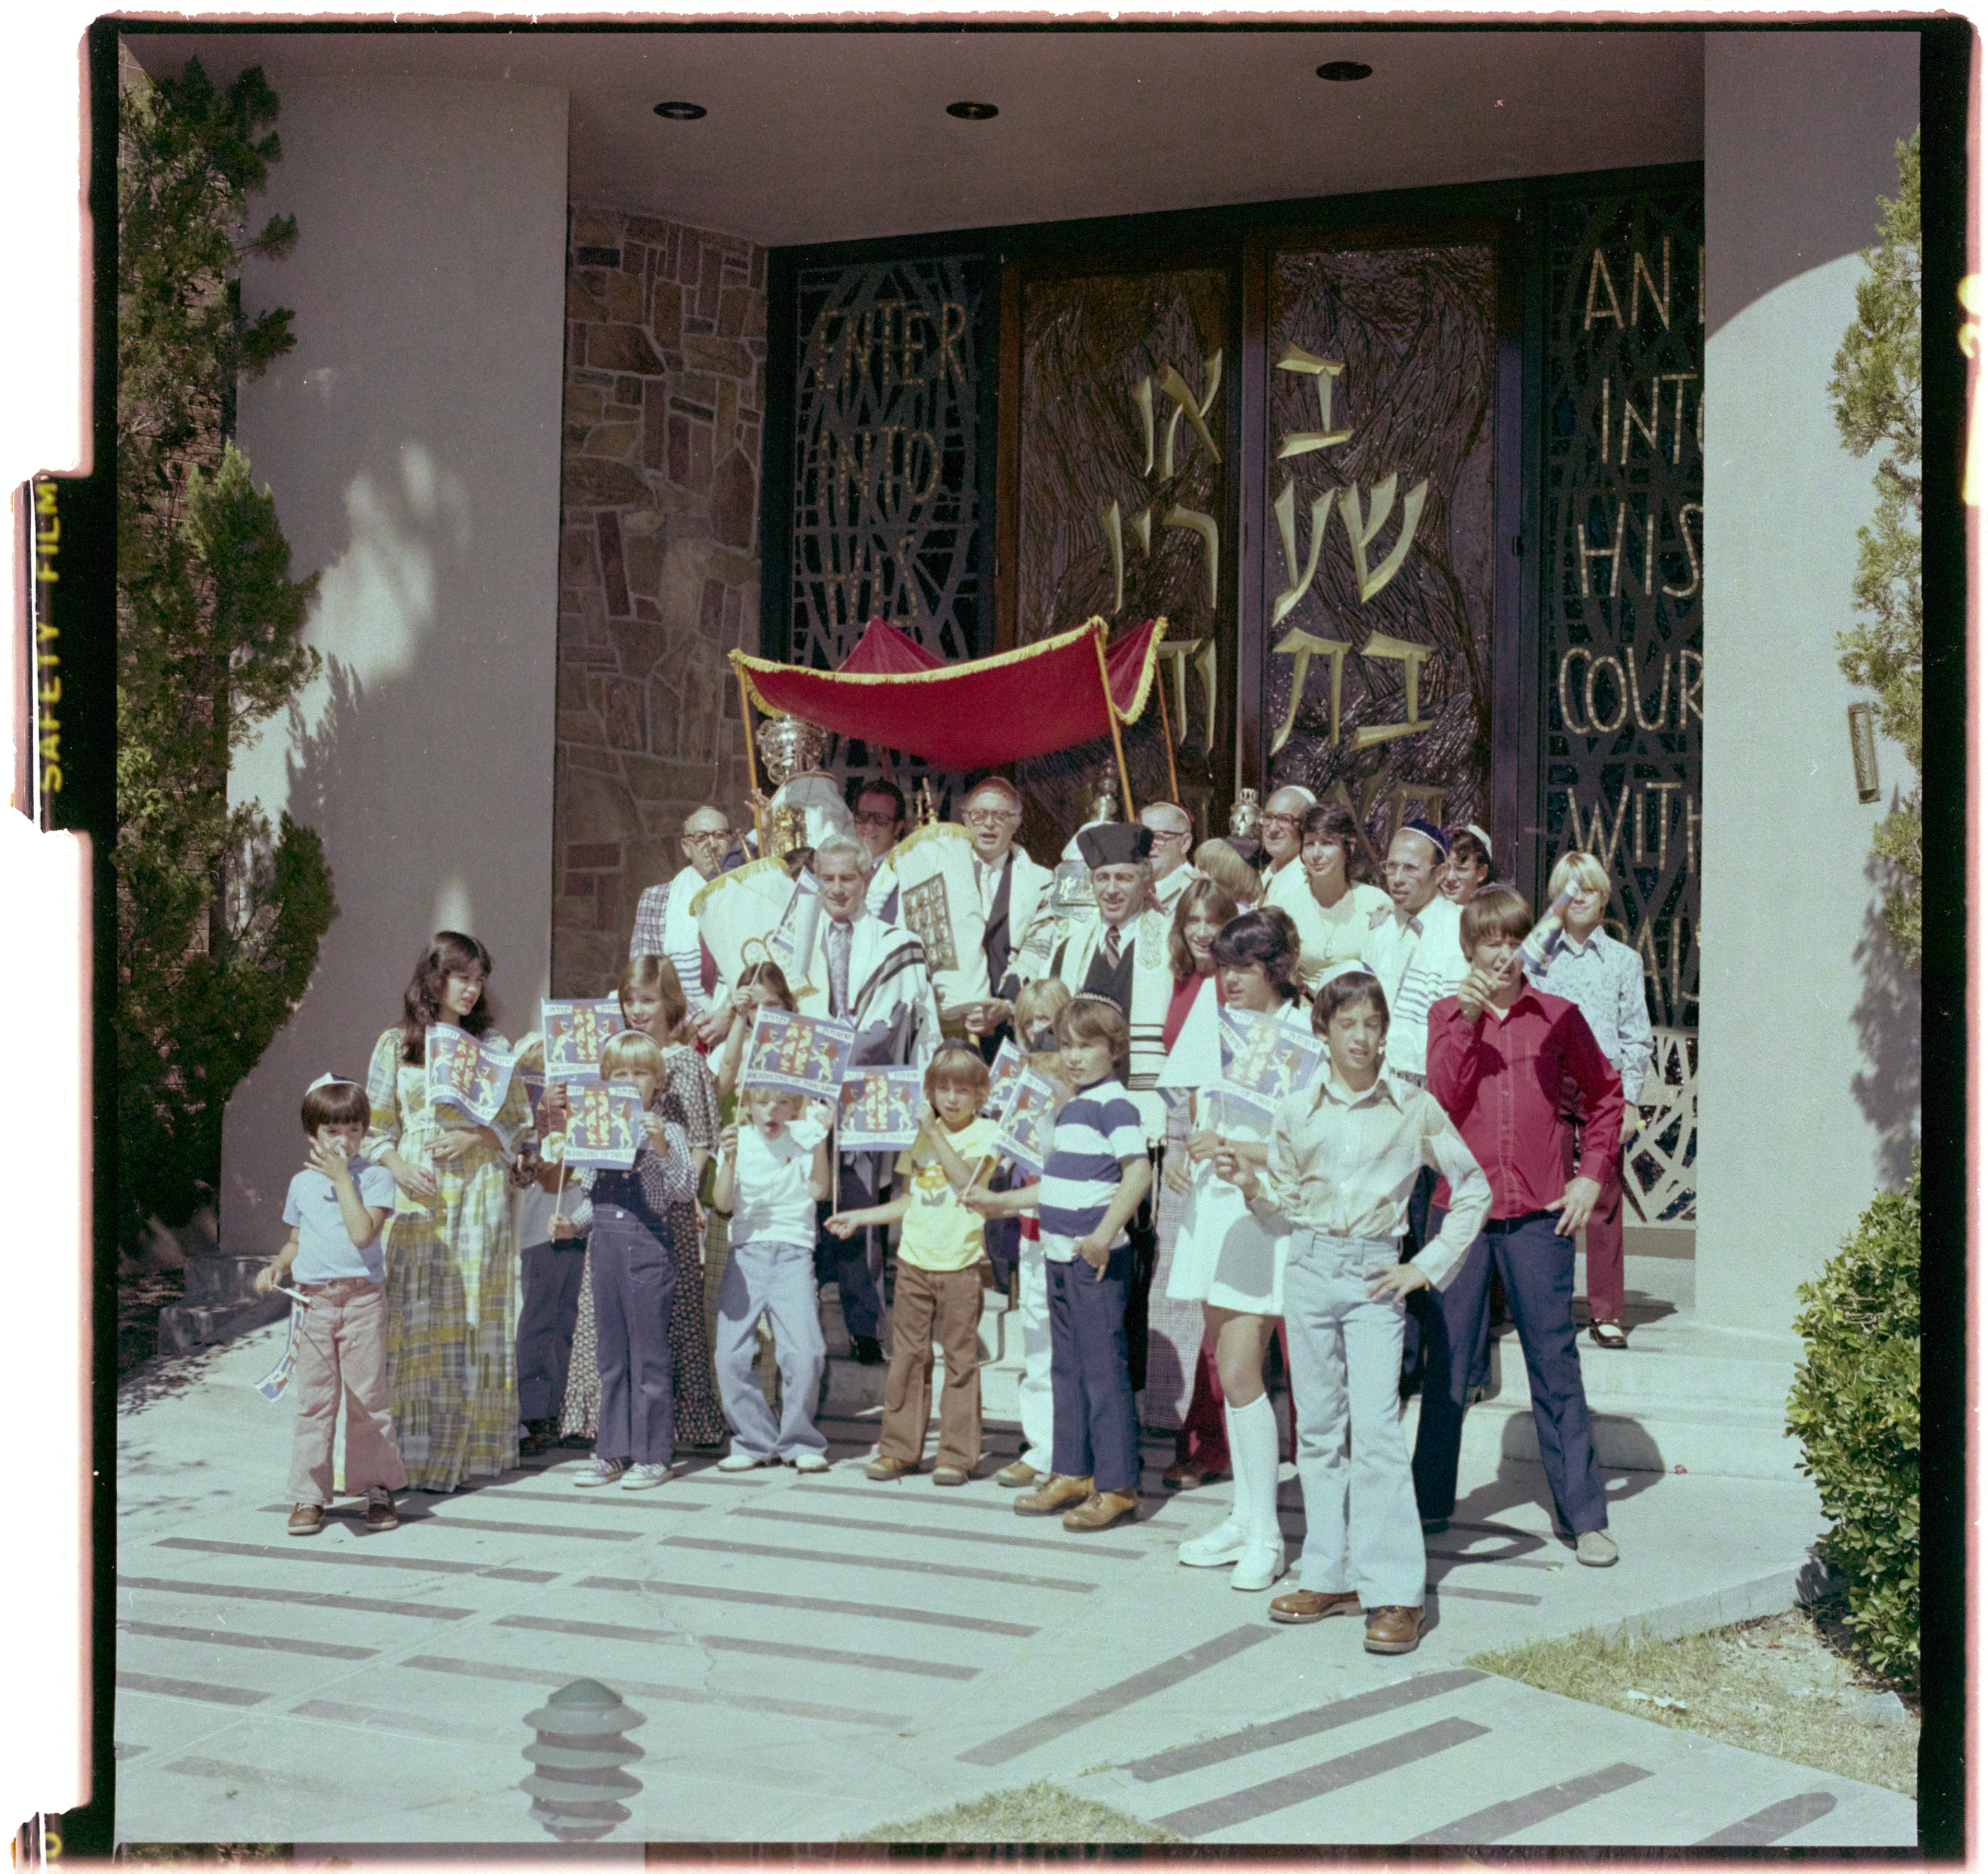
[1414,1206,1608,1536]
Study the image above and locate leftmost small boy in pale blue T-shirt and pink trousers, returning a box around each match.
[254,1073,408,1536]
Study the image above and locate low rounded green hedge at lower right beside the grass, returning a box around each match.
[1787,1159,1918,1679]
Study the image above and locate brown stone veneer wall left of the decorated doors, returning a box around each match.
[552,208,765,995]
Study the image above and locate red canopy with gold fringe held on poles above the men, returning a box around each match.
[732,618,1167,769]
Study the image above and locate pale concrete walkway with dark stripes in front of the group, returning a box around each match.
[115,1328,1917,1858]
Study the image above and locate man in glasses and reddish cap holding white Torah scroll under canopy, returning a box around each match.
[869,775,1055,1061]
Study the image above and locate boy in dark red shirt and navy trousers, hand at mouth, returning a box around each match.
[1414,886,1622,1568]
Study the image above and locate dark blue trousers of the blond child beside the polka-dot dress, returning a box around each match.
[588,1205,676,1465]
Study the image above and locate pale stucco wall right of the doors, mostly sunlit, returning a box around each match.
[1698,34,1918,1330]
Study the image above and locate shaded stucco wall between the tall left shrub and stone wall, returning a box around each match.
[220,76,567,1252]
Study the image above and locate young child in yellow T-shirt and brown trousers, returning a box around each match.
[827,1043,998,1484]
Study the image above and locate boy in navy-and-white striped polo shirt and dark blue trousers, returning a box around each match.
[963,995,1153,1530]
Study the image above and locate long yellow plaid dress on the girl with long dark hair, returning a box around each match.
[364,1028,528,1490]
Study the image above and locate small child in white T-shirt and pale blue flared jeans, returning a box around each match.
[711,1087,829,1471]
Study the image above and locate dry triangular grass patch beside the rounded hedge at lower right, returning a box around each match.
[1469,1612,1918,1797]
